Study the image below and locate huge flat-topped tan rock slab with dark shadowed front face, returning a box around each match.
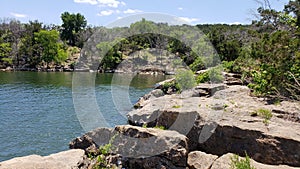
[128,86,300,166]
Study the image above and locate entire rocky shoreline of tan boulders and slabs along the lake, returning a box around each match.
[0,80,300,169]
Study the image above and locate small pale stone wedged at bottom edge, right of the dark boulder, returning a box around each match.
[187,151,218,169]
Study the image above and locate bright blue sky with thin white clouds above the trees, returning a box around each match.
[0,0,288,26]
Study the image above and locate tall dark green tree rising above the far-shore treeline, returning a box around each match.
[61,12,87,46]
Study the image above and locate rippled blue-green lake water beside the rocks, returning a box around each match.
[0,72,166,161]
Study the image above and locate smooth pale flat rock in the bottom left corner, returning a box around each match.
[0,149,84,169]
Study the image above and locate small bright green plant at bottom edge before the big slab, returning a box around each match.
[230,153,255,169]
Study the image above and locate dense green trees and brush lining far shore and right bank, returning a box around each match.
[0,0,300,100]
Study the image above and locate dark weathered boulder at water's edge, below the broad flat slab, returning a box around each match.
[70,125,188,169]
